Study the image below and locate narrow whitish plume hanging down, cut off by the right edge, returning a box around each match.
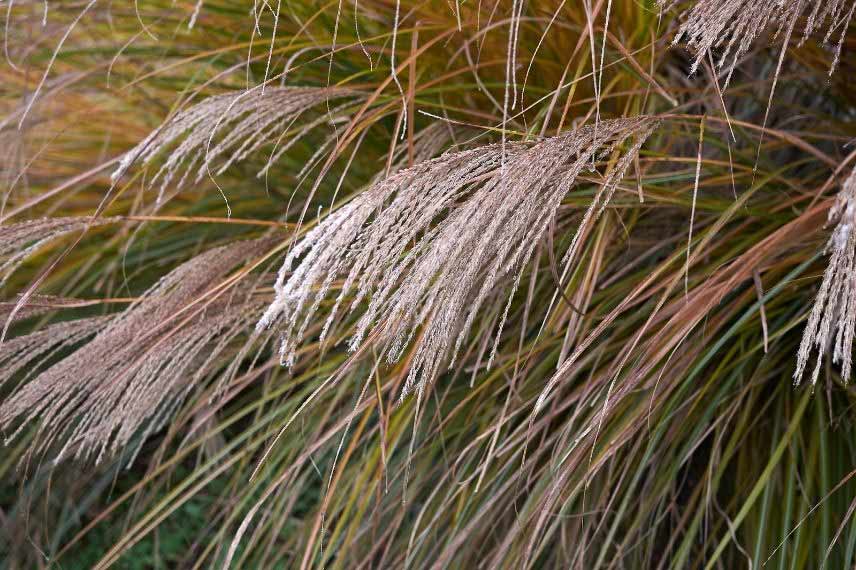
[794,166,856,384]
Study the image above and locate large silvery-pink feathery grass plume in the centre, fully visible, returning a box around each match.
[258,117,657,397]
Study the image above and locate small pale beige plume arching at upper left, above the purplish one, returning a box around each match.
[108,87,364,194]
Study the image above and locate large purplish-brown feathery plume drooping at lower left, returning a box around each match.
[0,235,268,459]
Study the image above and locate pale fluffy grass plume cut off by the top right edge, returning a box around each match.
[658,0,856,84]
